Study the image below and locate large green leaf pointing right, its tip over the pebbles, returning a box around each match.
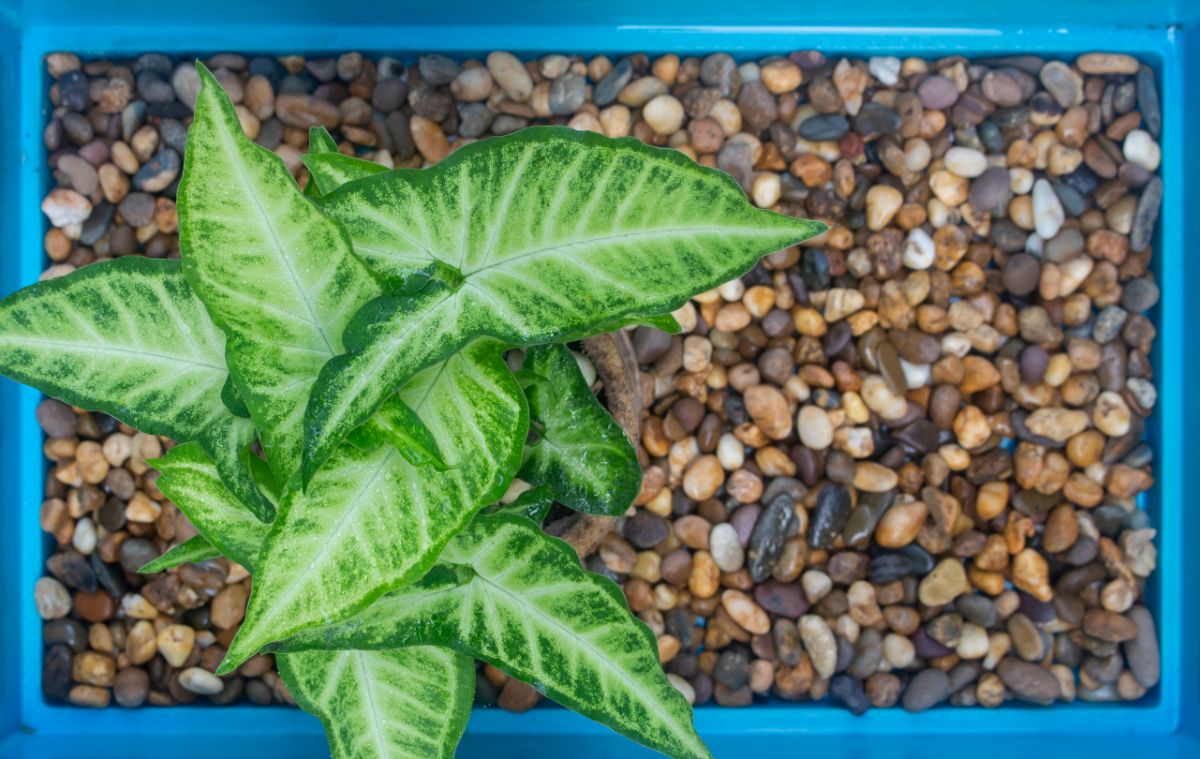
[304,127,824,477]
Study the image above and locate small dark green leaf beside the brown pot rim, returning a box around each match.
[517,343,642,516]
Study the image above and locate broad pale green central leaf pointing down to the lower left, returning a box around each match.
[218,341,528,673]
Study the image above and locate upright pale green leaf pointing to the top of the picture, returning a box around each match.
[178,64,380,484]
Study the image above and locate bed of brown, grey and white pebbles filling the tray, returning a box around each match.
[36,45,1162,712]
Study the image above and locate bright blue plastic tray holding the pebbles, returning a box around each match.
[0,0,1200,759]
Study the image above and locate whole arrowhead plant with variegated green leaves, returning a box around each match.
[11,65,823,759]
